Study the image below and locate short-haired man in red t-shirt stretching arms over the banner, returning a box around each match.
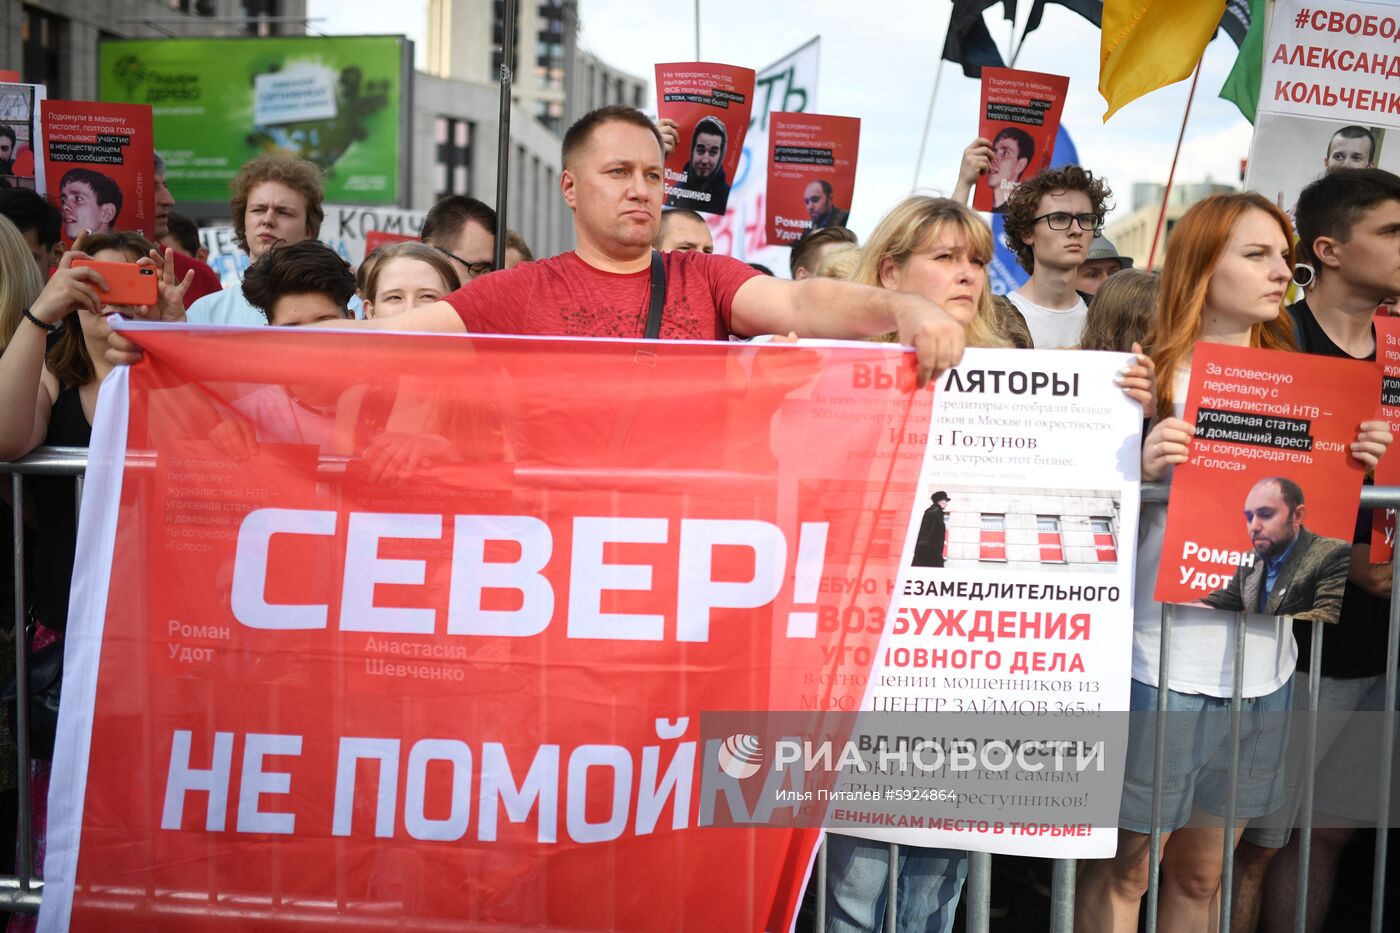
[108,106,963,382]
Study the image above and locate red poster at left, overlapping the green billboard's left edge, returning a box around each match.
[42,101,155,245]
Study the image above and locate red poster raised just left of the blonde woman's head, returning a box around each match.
[767,113,861,245]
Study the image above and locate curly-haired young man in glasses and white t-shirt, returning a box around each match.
[1004,165,1113,350]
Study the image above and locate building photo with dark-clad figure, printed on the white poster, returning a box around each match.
[910,486,1121,573]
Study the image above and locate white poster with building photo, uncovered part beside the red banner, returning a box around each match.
[826,350,1142,857]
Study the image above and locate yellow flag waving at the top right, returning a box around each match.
[1099,0,1225,122]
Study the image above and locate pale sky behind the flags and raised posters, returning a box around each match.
[308,0,1253,234]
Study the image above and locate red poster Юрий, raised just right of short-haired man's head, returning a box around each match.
[657,62,753,214]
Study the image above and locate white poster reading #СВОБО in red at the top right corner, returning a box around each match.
[1245,0,1400,210]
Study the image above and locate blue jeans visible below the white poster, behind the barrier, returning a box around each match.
[825,832,967,933]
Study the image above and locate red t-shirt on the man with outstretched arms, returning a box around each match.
[444,252,762,340]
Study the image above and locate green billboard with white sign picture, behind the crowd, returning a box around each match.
[98,36,413,205]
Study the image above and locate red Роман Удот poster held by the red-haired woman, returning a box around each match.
[1155,343,1380,622]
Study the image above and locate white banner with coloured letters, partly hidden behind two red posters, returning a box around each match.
[708,36,822,279]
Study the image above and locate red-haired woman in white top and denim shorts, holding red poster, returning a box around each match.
[1075,193,1392,933]
